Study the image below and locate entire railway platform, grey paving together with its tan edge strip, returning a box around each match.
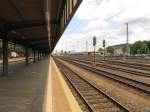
[0,57,81,112]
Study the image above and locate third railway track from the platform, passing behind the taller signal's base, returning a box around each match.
[66,59,150,78]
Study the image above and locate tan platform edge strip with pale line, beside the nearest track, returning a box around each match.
[43,58,82,112]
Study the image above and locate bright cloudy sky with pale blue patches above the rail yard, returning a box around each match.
[54,0,150,52]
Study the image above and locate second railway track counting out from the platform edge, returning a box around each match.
[59,59,150,95]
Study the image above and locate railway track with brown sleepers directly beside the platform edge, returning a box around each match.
[56,60,129,112]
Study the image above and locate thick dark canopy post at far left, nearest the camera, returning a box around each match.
[3,39,8,76]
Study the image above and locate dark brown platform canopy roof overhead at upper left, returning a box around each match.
[0,0,82,52]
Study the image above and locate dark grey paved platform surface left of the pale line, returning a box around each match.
[0,58,49,112]
